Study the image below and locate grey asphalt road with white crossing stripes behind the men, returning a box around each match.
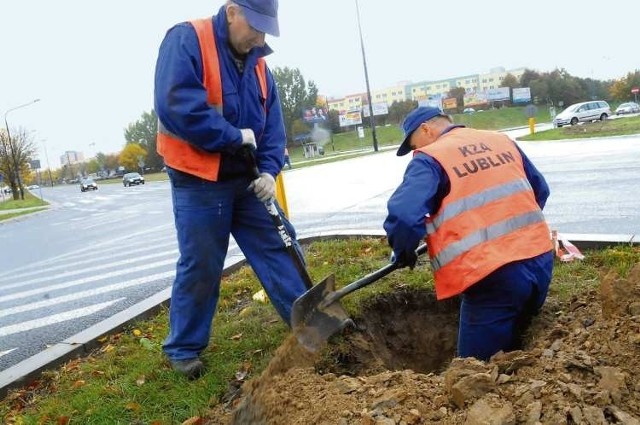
[0,131,640,370]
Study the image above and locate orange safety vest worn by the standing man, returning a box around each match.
[156,18,267,181]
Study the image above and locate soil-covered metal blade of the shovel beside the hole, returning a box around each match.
[291,275,353,352]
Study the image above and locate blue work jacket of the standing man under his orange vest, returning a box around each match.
[155,6,286,180]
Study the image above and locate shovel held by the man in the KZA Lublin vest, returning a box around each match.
[291,244,427,352]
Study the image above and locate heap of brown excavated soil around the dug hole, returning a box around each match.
[207,264,640,425]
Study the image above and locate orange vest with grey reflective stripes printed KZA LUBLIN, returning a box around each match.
[419,128,552,299]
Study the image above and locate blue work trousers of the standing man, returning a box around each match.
[163,169,306,360]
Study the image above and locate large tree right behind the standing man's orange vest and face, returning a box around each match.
[273,67,318,141]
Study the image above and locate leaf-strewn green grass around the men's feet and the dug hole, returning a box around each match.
[0,238,640,425]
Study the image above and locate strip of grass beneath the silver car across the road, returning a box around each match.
[518,117,640,140]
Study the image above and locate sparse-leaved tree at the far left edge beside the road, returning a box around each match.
[0,128,36,200]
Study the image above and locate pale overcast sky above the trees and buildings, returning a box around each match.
[0,0,640,168]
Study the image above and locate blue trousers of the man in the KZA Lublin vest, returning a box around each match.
[458,252,553,360]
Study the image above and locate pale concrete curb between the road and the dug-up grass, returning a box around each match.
[0,229,640,399]
